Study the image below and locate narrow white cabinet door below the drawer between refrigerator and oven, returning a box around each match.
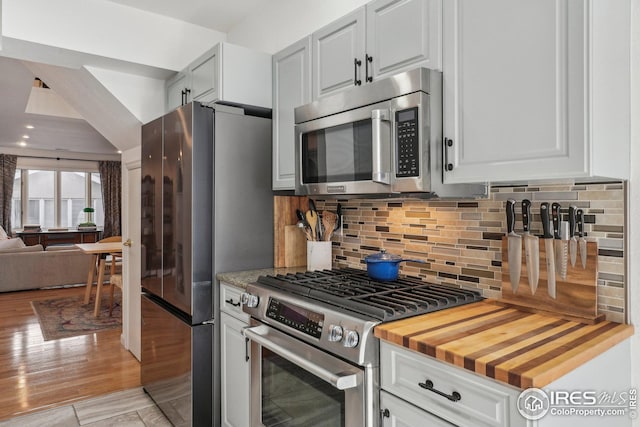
[220,313,250,427]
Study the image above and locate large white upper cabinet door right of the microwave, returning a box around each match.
[443,0,588,183]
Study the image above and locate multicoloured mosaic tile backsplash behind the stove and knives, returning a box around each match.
[315,182,627,322]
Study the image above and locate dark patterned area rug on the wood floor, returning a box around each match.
[31,293,122,341]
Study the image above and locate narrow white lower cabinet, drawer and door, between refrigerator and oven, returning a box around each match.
[220,284,251,427]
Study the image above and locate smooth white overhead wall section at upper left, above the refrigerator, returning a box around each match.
[0,0,226,71]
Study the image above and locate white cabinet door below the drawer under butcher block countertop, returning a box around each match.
[380,390,453,427]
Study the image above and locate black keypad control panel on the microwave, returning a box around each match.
[396,107,420,178]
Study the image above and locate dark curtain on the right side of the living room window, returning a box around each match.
[98,161,122,238]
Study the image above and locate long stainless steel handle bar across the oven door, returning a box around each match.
[243,325,360,390]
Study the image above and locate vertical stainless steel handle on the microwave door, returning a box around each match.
[371,109,391,185]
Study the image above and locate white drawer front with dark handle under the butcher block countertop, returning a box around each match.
[380,341,525,427]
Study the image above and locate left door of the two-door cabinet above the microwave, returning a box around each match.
[312,6,365,100]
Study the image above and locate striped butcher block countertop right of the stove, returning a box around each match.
[375,301,633,389]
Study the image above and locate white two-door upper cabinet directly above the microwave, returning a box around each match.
[312,0,442,99]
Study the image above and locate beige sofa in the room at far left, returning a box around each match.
[0,239,93,292]
